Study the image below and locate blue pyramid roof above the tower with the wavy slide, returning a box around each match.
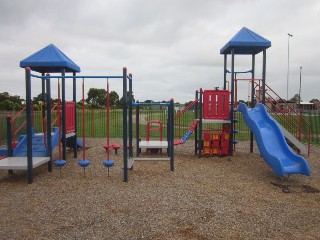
[220,27,271,54]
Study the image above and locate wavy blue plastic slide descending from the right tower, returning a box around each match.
[238,103,310,176]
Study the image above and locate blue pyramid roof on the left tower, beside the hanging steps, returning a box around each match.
[20,44,80,73]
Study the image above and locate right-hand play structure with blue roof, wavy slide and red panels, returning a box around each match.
[172,28,310,176]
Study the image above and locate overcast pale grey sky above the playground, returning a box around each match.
[0,0,320,103]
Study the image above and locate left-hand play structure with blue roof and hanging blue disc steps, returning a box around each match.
[0,44,174,183]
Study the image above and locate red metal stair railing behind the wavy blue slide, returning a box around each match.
[254,82,311,156]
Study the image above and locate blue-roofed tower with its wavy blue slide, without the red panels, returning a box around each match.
[220,28,310,176]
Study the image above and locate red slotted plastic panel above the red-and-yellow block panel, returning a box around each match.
[203,90,230,120]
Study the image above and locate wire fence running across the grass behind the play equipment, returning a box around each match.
[0,109,320,146]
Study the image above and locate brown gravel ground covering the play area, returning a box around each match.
[0,139,320,239]
